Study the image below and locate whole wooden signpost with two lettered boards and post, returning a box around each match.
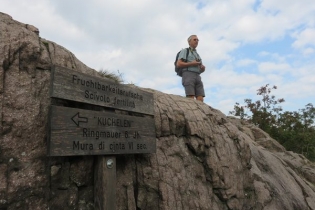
[48,66,156,210]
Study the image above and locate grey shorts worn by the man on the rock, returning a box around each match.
[182,71,205,97]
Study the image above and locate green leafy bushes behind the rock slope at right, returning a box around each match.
[229,84,315,161]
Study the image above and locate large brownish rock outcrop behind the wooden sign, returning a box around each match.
[0,13,315,210]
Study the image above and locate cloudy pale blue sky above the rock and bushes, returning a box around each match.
[0,0,315,114]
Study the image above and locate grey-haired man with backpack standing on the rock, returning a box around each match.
[176,35,206,101]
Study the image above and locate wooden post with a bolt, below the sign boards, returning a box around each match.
[94,156,116,210]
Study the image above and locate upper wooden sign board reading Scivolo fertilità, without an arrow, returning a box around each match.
[51,66,154,115]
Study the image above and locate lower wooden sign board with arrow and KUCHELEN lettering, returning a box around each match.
[48,105,156,156]
